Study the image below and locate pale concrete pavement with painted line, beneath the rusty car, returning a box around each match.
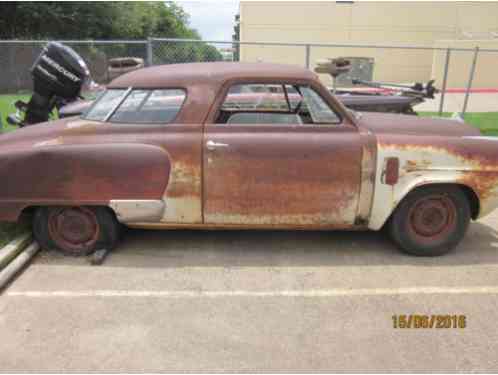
[0,212,498,372]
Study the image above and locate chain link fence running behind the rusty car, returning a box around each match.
[0,38,498,113]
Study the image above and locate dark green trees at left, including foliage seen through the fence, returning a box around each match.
[0,1,222,86]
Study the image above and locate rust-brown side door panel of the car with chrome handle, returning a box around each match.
[203,83,361,228]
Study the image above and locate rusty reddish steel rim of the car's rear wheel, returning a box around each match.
[48,207,100,253]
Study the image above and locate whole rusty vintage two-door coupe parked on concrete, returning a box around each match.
[0,63,498,255]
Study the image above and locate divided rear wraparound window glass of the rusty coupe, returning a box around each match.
[83,89,186,124]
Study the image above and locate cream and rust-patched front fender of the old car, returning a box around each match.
[368,141,498,230]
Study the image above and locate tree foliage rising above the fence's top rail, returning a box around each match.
[0,1,199,39]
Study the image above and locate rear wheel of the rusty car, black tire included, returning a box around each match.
[33,206,122,256]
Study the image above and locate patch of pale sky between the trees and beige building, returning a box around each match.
[175,0,239,41]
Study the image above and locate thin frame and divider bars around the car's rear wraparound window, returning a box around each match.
[80,86,188,125]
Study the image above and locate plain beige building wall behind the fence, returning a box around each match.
[240,0,498,86]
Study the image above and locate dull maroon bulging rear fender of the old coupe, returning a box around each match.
[0,143,171,220]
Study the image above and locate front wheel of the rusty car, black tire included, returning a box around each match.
[387,185,471,256]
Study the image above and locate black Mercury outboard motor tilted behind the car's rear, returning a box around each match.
[7,42,90,127]
